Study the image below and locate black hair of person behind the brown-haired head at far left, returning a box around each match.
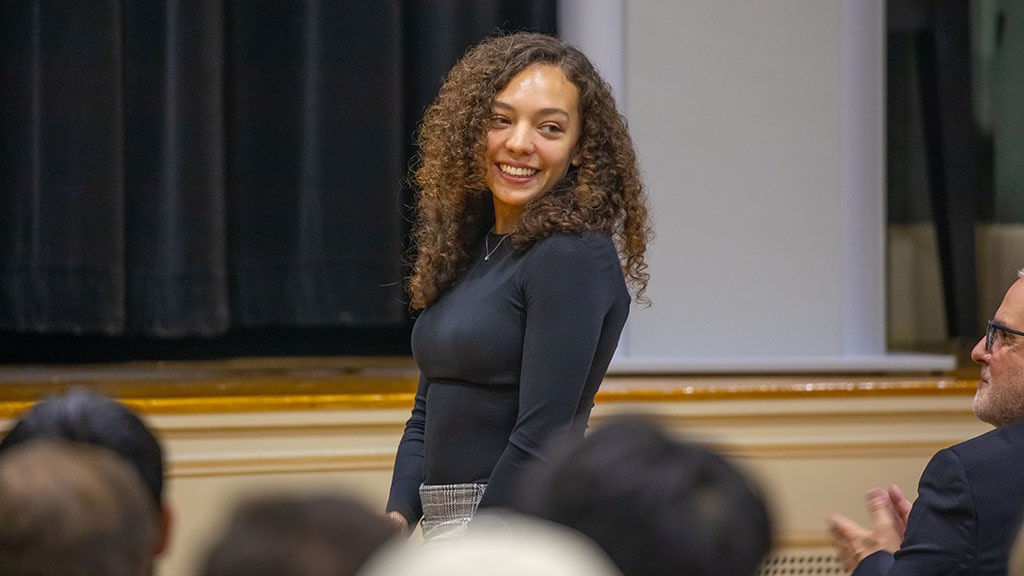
[0,389,164,506]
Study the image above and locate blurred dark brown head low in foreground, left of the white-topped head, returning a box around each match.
[201,495,396,576]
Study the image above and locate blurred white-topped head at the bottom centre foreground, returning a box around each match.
[359,510,622,576]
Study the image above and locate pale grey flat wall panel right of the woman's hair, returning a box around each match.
[623,0,886,360]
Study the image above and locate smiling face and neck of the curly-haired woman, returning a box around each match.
[485,64,582,234]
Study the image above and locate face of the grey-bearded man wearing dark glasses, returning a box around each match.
[971,279,1024,426]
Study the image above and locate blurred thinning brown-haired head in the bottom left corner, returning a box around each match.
[0,441,157,576]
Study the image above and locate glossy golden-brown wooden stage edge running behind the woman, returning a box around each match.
[0,358,977,418]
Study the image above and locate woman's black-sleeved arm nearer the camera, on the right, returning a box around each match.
[480,237,629,507]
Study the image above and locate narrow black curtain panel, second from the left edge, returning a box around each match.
[123,0,230,336]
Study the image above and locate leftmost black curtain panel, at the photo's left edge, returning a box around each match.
[0,1,126,332]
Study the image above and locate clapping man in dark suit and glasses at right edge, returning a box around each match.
[827,270,1024,576]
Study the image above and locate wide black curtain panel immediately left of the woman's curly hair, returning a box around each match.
[227,1,408,325]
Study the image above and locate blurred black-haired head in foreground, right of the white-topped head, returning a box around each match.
[519,418,771,576]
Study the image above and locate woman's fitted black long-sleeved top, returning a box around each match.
[387,227,630,524]
